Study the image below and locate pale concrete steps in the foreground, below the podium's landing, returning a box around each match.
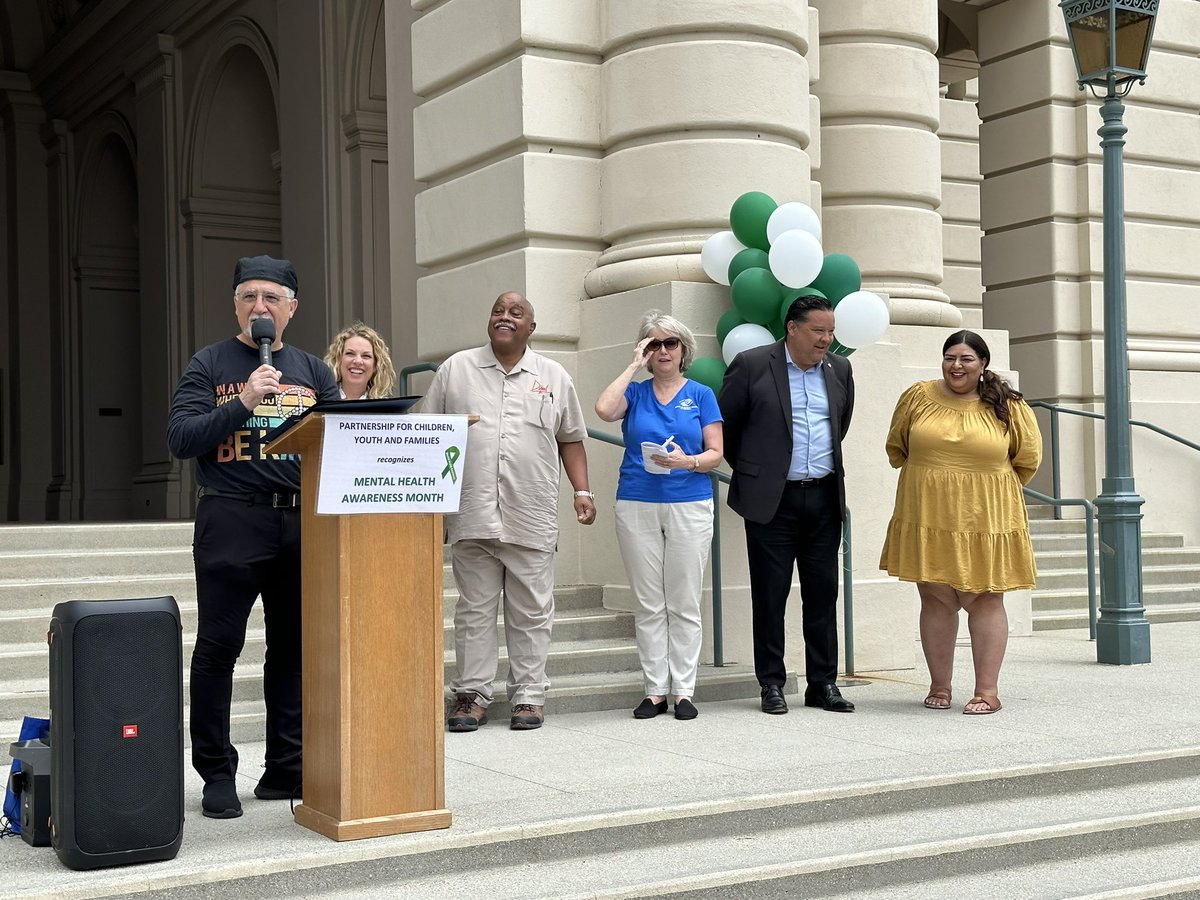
[94,748,1200,900]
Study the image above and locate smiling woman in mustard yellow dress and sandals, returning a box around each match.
[880,331,1042,715]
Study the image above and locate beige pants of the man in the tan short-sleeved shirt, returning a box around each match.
[449,540,554,707]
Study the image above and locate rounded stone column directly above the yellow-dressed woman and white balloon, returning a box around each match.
[812,0,962,328]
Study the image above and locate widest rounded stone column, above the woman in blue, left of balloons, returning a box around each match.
[587,0,812,296]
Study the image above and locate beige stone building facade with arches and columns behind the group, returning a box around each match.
[0,0,1200,668]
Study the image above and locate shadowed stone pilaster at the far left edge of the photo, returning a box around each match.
[0,82,54,522]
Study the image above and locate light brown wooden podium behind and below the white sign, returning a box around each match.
[264,413,450,841]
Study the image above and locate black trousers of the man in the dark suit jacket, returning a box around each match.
[745,475,841,688]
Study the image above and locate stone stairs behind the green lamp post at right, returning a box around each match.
[1030,504,1200,631]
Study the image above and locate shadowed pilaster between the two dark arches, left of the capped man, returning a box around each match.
[126,35,192,518]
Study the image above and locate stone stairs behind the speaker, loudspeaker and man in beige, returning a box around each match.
[0,522,763,742]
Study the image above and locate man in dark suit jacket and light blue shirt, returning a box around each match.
[718,295,854,714]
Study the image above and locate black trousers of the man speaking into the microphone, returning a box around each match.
[191,497,301,784]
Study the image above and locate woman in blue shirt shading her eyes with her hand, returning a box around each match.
[596,310,725,719]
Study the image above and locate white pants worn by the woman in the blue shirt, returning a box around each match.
[617,500,713,697]
